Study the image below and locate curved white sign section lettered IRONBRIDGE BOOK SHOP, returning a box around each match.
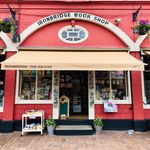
[37,12,109,26]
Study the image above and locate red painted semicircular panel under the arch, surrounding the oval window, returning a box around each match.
[21,21,127,48]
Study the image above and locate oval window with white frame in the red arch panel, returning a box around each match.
[58,25,88,43]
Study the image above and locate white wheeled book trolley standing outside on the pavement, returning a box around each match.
[21,110,44,136]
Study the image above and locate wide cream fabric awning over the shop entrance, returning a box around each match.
[1,51,144,70]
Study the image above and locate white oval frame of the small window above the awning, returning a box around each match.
[58,25,89,44]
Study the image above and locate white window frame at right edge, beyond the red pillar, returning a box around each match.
[141,56,150,109]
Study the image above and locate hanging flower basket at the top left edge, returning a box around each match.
[0,18,15,33]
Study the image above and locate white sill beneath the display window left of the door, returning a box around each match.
[15,100,53,104]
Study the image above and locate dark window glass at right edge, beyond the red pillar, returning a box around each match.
[143,55,150,104]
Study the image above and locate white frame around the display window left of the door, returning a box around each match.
[15,71,54,104]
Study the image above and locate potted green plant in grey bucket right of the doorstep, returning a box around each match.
[93,118,103,134]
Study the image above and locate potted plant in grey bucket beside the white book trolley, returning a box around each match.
[45,118,56,135]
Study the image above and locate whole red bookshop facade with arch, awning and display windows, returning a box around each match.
[0,0,150,132]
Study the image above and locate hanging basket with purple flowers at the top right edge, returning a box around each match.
[133,20,150,35]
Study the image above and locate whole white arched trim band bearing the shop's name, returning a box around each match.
[17,12,137,51]
